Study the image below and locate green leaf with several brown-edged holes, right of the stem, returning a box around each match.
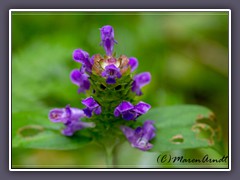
[138,105,221,152]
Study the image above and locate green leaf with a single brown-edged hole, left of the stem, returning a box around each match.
[12,110,91,150]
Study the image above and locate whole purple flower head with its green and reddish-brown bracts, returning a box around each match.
[49,25,155,151]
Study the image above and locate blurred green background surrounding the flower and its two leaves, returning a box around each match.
[12,12,229,168]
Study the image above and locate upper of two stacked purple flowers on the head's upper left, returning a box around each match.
[73,49,93,73]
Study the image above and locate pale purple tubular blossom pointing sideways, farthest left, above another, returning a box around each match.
[48,106,85,123]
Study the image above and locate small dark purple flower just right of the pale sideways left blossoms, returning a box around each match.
[82,97,102,117]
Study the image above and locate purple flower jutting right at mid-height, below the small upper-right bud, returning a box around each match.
[132,72,151,96]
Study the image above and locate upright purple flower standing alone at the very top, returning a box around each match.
[100,25,117,56]
